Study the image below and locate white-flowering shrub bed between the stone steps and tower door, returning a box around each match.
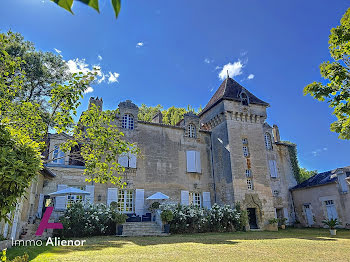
[161,204,247,233]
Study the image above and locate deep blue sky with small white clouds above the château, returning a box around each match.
[0,0,350,171]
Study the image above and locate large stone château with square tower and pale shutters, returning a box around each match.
[1,77,296,239]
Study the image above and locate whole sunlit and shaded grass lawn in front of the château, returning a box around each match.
[8,228,350,262]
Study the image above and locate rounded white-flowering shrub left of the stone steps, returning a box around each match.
[55,203,117,237]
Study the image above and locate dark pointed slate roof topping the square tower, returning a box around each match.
[200,77,269,115]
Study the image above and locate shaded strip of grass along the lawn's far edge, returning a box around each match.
[8,228,350,259]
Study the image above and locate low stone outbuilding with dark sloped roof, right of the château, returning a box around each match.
[292,166,350,228]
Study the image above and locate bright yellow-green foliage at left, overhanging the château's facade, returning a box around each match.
[0,33,137,221]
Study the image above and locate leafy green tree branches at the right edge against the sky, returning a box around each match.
[304,8,350,139]
